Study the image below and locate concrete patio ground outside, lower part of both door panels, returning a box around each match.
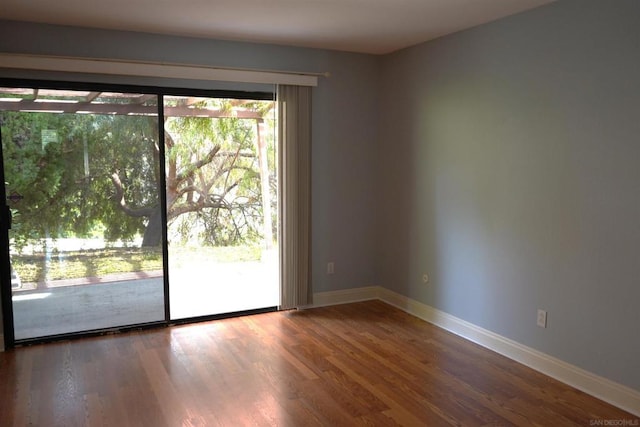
[13,262,279,340]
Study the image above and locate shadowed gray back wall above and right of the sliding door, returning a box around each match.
[0,21,379,302]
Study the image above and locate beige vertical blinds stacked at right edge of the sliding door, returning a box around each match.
[277,85,313,309]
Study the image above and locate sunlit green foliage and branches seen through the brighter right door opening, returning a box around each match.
[165,99,276,246]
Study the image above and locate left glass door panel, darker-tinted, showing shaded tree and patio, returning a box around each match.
[0,88,165,340]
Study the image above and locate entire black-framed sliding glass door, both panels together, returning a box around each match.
[0,85,280,345]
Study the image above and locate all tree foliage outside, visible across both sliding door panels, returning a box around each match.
[0,99,276,249]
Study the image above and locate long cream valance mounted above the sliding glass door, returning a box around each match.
[0,53,330,86]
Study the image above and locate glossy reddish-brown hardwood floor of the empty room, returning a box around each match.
[0,301,638,427]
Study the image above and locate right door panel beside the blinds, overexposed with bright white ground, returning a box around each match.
[164,96,279,319]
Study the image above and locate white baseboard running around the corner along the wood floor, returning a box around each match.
[310,286,640,416]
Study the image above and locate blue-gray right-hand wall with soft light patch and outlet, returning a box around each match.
[376,0,640,390]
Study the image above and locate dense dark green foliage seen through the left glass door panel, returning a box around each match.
[0,111,158,248]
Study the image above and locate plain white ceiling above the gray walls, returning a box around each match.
[0,0,554,54]
